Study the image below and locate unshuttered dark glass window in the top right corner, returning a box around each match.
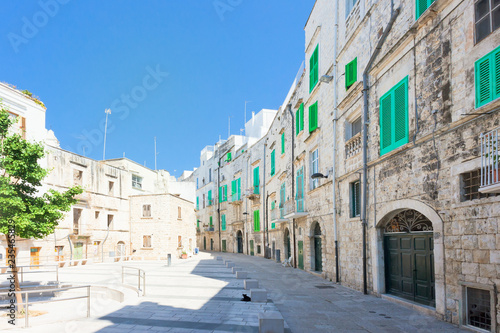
[474,0,500,43]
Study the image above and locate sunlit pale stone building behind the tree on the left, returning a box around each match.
[0,83,195,265]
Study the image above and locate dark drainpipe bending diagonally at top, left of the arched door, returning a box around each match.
[361,2,400,294]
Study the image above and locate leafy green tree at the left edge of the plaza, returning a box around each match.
[0,108,83,311]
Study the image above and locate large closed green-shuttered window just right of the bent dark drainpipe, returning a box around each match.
[380,76,408,155]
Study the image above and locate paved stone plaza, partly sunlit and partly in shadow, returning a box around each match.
[0,253,468,333]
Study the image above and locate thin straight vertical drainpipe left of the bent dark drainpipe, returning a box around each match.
[332,0,340,283]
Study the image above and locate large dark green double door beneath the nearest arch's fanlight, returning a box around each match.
[384,233,435,306]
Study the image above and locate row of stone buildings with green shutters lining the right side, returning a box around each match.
[193,0,500,332]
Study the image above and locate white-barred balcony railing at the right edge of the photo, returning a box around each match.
[479,127,500,193]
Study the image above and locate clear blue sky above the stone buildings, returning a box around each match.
[0,0,314,176]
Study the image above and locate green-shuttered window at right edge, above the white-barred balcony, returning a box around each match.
[474,44,500,108]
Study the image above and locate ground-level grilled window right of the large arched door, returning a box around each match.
[465,287,495,331]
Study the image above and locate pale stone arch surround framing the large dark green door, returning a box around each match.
[369,199,446,314]
